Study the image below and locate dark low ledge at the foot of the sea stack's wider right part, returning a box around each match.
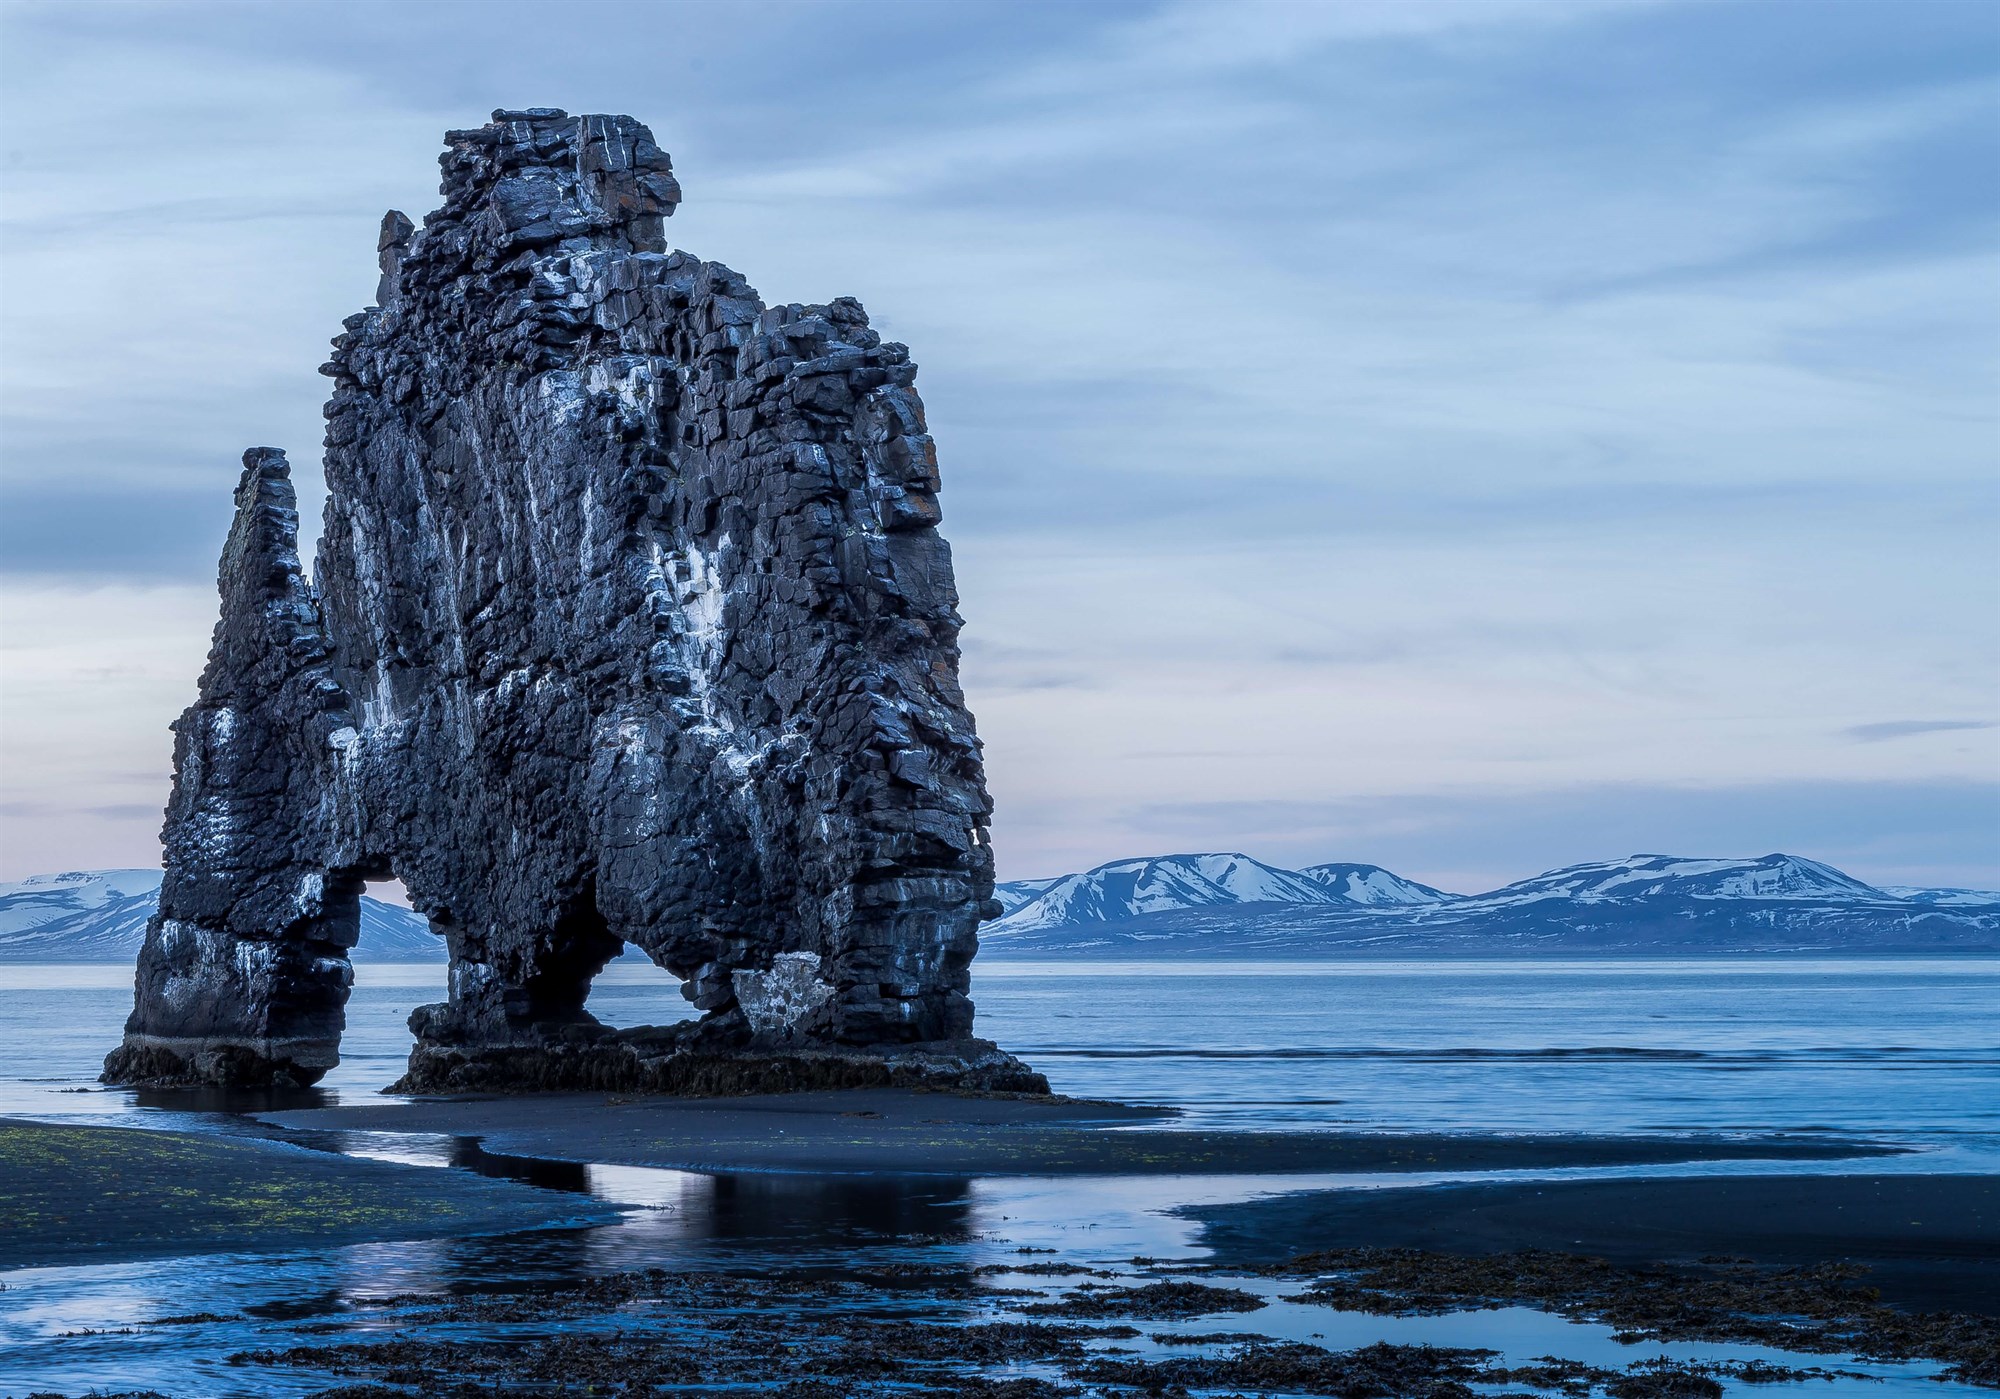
[386,1025,1048,1097]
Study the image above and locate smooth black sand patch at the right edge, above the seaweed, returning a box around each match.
[1178,1175,2000,1315]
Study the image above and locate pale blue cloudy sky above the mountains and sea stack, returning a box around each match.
[0,0,2000,889]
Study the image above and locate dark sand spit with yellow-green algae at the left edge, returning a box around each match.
[0,1117,618,1271]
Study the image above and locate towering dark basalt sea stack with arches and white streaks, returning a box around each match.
[104,110,1046,1091]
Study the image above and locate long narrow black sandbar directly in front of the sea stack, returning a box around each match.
[258,1089,1896,1175]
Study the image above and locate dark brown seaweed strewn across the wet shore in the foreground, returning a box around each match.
[78,1249,2000,1399]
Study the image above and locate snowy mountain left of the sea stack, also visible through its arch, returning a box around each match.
[0,869,444,961]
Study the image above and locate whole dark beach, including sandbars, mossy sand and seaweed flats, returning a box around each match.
[0,1091,2000,1399]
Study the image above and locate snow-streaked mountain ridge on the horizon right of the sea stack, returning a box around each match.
[980,853,2000,957]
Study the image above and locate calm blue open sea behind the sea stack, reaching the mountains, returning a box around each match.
[0,959,2000,1169]
